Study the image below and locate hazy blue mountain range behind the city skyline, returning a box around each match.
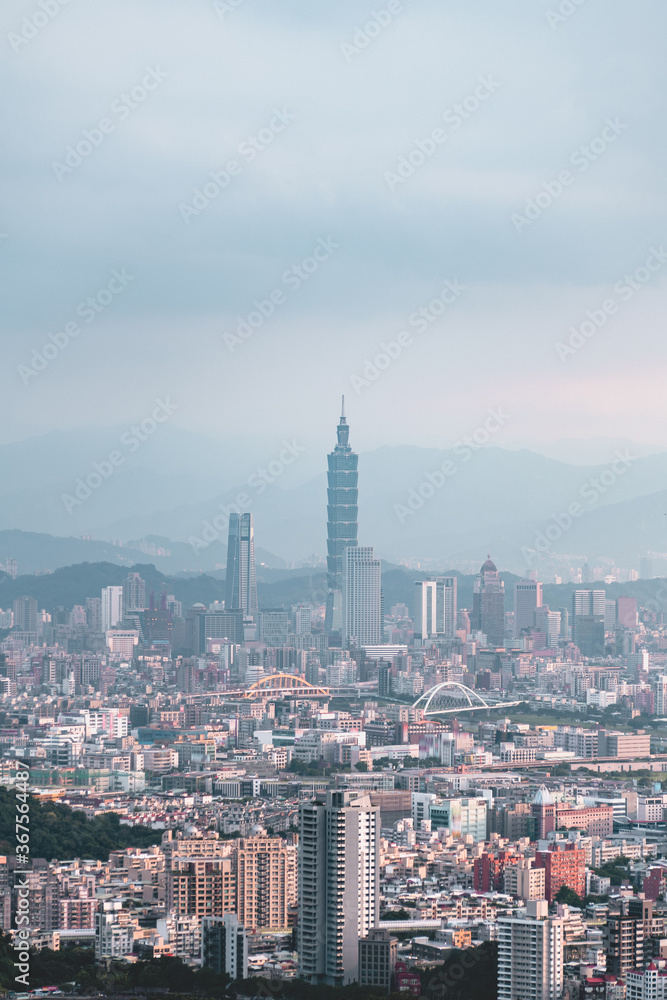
[0,426,667,579]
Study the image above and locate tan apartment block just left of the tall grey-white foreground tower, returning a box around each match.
[236,837,297,933]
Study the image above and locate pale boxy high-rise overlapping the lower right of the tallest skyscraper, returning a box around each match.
[343,545,382,646]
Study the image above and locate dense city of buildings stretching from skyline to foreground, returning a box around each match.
[0,408,667,1000]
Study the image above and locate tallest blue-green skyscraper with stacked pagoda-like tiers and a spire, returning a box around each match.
[324,396,359,635]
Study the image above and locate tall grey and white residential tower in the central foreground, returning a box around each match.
[297,790,380,986]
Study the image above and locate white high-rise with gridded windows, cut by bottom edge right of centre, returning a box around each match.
[498,900,564,1000]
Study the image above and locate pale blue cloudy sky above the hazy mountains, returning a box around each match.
[0,0,667,458]
